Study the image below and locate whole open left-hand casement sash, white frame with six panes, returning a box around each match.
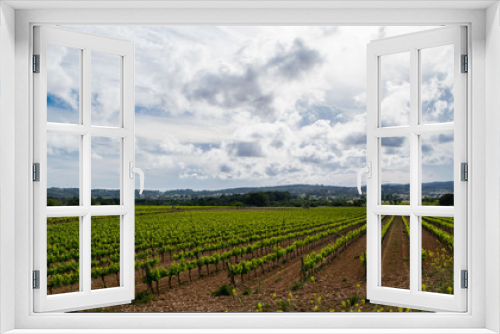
[33,26,135,312]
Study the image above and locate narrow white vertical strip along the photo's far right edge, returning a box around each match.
[485,3,500,332]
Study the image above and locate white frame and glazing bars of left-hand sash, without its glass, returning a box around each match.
[33,26,135,312]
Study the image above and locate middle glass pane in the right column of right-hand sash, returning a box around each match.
[420,133,454,206]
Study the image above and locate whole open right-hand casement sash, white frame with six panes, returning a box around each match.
[367,27,467,312]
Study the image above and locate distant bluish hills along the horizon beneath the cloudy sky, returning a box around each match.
[47,181,453,199]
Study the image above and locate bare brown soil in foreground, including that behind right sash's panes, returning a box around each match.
[72,217,452,312]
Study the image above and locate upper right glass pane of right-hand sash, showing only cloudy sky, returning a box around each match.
[420,45,454,123]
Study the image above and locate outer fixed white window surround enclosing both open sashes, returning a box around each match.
[0,1,500,333]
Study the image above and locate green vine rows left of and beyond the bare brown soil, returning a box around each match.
[47,207,366,293]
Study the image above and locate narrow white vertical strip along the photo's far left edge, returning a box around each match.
[0,3,15,333]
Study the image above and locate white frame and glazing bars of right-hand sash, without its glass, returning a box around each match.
[366,26,468,312]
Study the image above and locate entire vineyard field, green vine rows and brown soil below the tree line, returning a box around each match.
[47,206,453,312]
